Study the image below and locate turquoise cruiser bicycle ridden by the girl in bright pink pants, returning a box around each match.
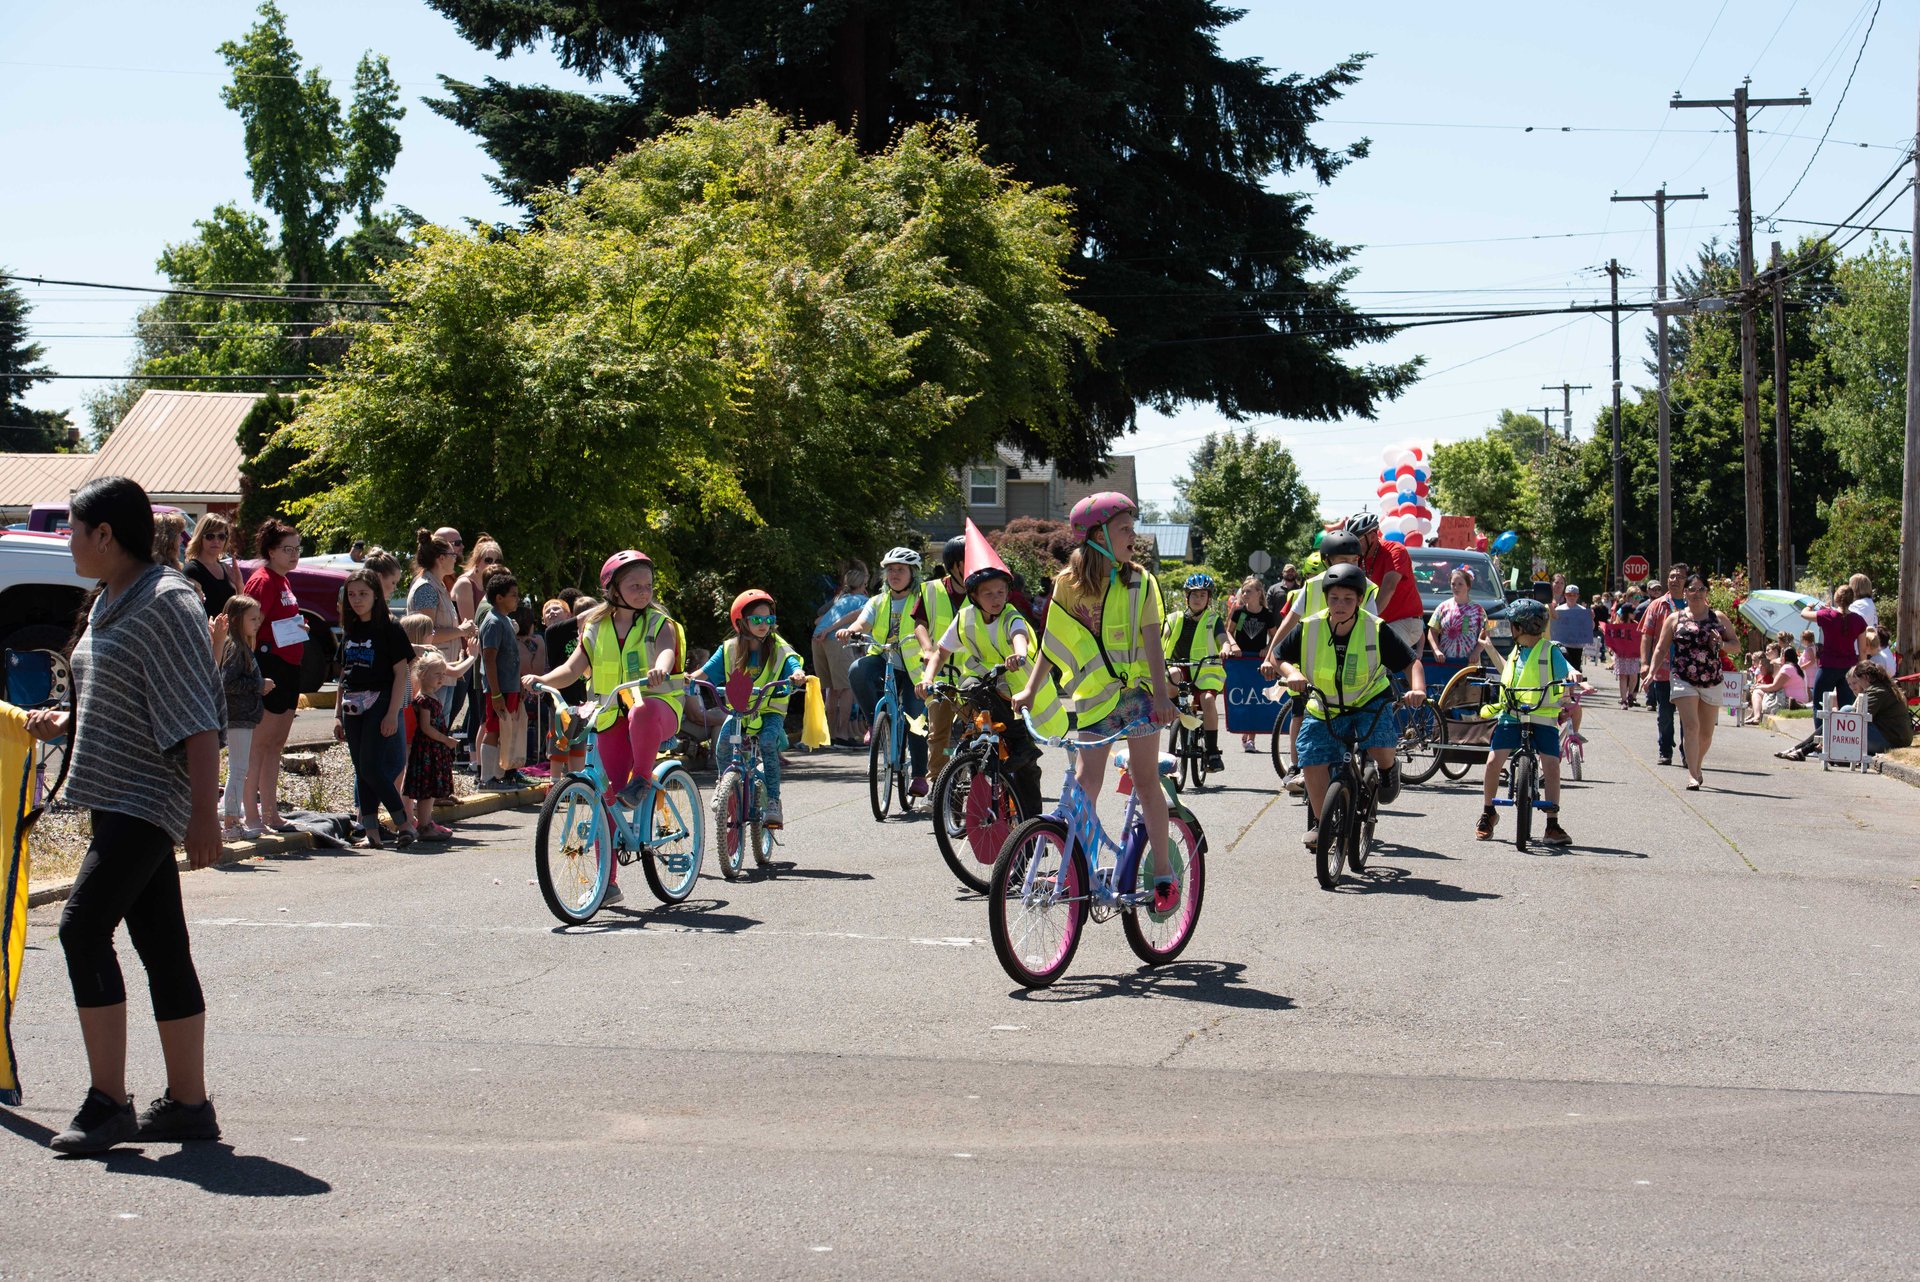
[530,679,707,925]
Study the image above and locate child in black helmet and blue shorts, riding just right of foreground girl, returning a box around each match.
[1277,564,1427,850]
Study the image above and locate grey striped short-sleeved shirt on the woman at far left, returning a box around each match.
[67,566,225,843]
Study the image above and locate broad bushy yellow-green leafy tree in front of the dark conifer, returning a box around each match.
[284,107,1100,631]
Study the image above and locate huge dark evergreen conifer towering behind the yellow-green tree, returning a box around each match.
[428,0,1417,476]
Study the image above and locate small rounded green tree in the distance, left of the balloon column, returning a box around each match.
[1177,428,1319,587]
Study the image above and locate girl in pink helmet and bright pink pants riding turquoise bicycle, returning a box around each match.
[522,547,687,904]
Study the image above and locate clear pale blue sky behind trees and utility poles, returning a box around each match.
[0,0,1920,529]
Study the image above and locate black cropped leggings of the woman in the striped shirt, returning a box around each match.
[60,810,207,1021]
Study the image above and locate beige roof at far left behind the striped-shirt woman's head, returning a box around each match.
[0,392,259,509]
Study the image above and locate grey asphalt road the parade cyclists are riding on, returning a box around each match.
[0,708,1920,1278]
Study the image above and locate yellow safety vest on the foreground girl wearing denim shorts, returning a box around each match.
[1027,570,1162,735]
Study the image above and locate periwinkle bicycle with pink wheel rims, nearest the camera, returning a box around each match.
[987,716,1206,988]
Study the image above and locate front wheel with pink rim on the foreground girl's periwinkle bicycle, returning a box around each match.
[987,818,1089,988]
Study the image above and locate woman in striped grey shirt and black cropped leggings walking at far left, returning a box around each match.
[27,476,221,1153]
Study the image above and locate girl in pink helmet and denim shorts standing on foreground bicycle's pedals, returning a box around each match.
[1014,489,1179,912]
